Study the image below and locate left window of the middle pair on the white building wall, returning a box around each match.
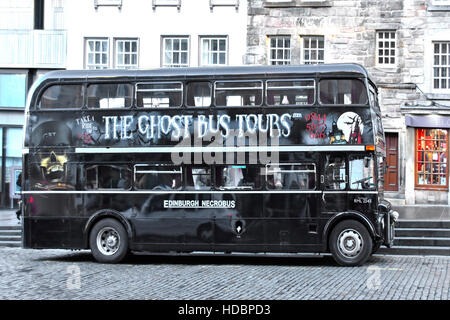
[162,37,189,67]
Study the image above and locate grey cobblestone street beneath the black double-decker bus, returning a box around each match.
[0,248,450,300]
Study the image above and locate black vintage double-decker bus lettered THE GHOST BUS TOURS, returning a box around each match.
[22,64,398,265]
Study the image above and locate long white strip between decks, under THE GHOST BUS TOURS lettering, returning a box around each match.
[75,145,366,153]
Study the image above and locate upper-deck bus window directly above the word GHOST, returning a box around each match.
[136,82,183,108]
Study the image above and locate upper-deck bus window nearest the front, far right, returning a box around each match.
[319,79,368,105]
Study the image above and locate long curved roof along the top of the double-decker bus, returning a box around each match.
[41,63,374,82]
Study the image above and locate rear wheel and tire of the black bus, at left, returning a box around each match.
[89,218,128,263]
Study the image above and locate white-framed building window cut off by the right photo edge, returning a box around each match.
[433,41,450,89]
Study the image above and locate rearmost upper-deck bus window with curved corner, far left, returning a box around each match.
[39,84,84,109]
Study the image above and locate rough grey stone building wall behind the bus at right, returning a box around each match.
[244,0,450,199]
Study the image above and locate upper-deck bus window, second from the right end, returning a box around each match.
[267,80,315,106]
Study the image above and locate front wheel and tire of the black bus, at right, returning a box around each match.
[329,220,373,266]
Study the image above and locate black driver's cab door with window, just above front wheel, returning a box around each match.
[320,153,348,215]
